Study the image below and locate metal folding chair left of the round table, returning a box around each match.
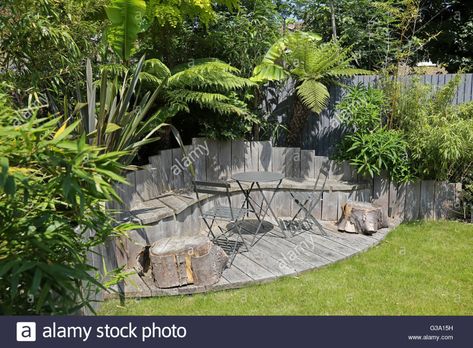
[193,181,249,265]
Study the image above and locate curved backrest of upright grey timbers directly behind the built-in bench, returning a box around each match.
[110,138,361,209]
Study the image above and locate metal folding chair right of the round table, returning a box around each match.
[283,162,330,236]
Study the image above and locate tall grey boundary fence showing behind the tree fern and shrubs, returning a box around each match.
[261,74,473,156]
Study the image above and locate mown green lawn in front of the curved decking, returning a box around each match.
[99,221,473,315]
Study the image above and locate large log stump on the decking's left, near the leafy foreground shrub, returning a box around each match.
[139,235,228,288]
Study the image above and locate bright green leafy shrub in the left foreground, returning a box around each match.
[0,98,136,315]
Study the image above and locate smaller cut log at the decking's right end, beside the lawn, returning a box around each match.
[338,202,388,234]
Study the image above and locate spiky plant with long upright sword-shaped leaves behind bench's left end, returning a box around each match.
[76,57,167,164]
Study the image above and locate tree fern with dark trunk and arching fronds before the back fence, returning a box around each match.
[252,32,370,146]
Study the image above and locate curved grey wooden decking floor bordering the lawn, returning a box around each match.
[112,222,390,297]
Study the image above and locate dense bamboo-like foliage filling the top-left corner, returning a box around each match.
[0,0,108,110]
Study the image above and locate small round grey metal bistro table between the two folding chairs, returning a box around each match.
[232,172,284,245]
